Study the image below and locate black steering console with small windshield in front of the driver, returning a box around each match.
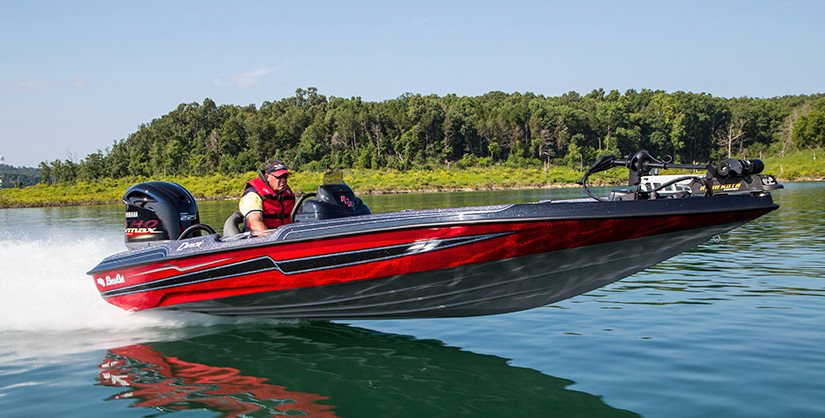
[294,171,372,222]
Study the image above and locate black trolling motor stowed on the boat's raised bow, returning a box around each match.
[579,151,783,200]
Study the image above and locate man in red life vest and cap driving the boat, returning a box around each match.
[238,161,295,231]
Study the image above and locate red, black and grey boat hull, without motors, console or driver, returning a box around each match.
[90,196,777,320]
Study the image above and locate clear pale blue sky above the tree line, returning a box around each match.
[0,0,825,166]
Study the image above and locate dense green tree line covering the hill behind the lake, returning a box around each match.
[39,88,825,184]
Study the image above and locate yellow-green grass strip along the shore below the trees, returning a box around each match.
[0,151,825,208]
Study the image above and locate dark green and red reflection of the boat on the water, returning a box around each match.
[97,322,636,417]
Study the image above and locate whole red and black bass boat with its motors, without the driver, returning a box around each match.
[88,151,782,320]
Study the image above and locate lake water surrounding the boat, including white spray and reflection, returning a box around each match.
[0,183,825,417]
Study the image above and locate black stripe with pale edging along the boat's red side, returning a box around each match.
[100,232,510,298]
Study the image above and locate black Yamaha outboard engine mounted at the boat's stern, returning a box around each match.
[123,181,200,249]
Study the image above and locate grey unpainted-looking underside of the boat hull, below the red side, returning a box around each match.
[159,220,739,319]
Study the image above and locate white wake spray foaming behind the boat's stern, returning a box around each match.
[0,234,232,332]
